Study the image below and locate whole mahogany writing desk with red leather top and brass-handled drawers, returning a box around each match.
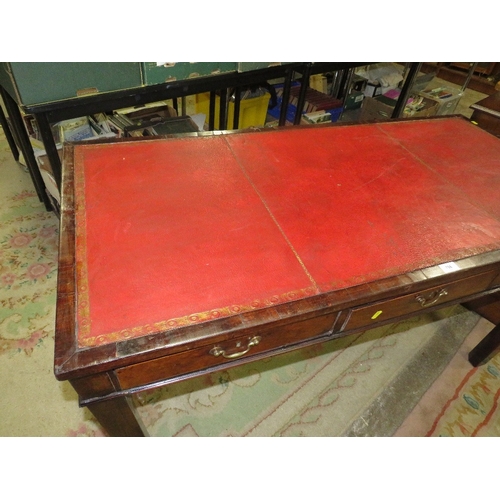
[55,116,500,436]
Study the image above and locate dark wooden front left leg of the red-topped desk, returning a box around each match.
[87,396,148,437]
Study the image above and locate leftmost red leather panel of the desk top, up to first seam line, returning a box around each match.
[75,138,316,345]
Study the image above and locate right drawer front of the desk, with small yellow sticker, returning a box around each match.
[341,271,497,331]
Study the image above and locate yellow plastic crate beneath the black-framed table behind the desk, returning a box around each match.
[196,92,271,130]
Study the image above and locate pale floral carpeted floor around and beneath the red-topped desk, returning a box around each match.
[0,129,500,436]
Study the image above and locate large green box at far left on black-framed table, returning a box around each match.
[0,62,142,106]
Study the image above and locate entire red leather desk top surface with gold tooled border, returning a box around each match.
[74,117,500,347]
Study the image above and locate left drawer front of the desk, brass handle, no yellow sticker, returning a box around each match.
[115,313,337,389]
